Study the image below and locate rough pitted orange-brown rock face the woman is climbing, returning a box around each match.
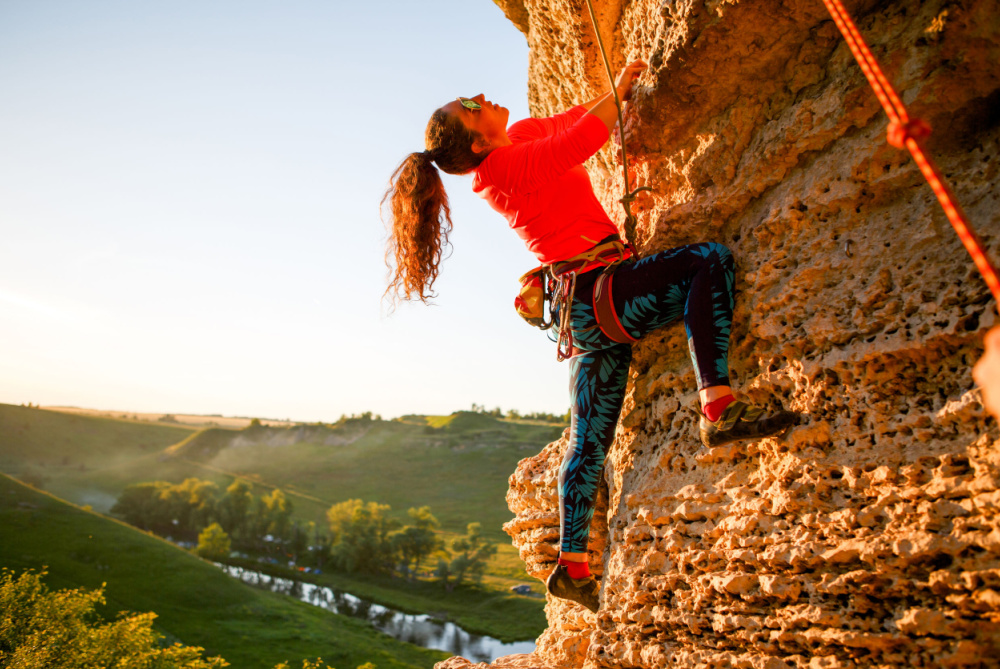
[439,0,1000,669]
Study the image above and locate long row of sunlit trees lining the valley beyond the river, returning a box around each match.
[111,478,496,590]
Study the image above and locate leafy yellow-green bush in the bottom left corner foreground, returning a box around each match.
[0,569,228,669]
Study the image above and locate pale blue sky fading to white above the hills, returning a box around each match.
[0,0,568,420]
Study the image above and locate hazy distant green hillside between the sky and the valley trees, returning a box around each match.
[0,405,563,543]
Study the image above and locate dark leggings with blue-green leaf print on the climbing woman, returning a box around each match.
[559,243,733,553]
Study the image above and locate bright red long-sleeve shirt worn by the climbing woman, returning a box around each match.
[472,106,618,265]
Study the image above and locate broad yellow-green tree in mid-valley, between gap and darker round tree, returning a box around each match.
[326,499,399,573]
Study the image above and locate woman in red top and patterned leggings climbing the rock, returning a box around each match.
[383,61,796,611]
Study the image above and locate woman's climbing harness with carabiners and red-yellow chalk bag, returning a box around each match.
[514,237,635,362]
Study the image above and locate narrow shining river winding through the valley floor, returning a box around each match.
[219,565,535,662]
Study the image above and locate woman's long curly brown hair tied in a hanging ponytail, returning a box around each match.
[380,109,486,305]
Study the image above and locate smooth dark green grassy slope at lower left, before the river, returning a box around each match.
[0,476,446,669]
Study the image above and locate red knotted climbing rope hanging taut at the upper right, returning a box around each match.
[823,0,1000,305]
